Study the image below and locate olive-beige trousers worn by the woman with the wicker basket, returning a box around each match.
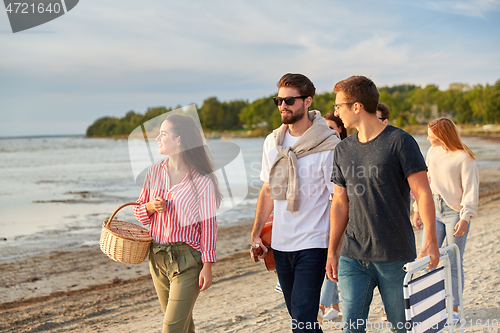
[149,242,203,333]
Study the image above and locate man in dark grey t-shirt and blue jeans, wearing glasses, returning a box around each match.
[326,76,439,332]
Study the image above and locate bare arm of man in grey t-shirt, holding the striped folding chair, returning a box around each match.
[408,171,440,269]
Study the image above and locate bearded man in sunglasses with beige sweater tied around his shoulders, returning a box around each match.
[251,74,340,332]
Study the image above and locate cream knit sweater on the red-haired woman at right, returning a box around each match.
[414,147,479,221]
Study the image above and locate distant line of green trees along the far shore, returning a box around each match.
[87,80,500,137]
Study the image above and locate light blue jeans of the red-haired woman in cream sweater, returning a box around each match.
[434,195,470,306]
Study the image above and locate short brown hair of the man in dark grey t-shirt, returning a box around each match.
[333,76,380,113]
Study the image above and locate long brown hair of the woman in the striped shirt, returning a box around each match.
[165,114,222,208]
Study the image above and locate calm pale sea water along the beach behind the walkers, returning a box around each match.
[0,136,500,257]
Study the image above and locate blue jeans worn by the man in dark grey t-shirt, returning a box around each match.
[338,257,407,333]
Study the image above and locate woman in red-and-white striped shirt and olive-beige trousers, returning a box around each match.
[134,115,222,333]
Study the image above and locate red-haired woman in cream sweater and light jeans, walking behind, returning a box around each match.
[413,118,479,321]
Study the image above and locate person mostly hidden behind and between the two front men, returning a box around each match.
[318,113,347,322]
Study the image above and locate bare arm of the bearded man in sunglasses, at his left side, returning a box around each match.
[250,182,274,259]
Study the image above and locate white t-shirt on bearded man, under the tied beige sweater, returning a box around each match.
[260,130,334,252]
